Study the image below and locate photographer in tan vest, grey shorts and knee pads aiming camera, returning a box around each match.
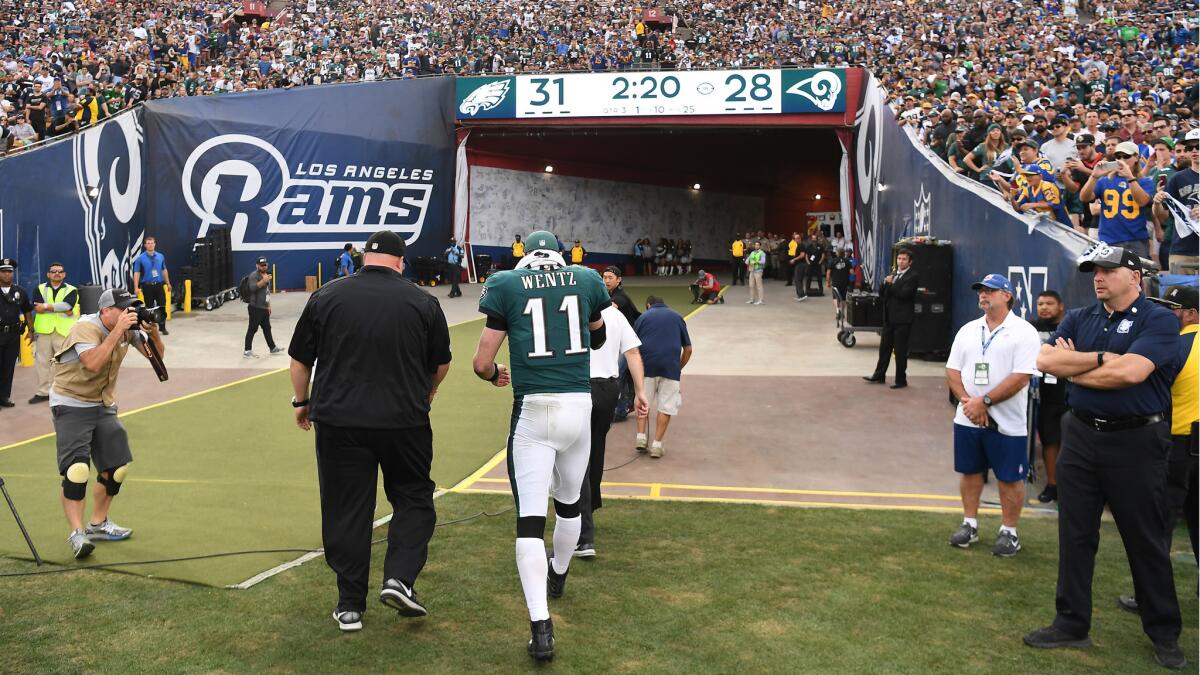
[50,289,164,558]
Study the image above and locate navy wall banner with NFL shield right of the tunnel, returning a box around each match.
[852,85,1094,327]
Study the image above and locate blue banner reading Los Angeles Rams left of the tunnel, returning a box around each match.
[145,78,455,288]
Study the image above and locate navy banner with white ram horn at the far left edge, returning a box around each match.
[0,109,146,289]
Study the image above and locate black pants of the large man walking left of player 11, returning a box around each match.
[316,423,437,611]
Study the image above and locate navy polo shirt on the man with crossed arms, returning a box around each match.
[1050,295,1183,418]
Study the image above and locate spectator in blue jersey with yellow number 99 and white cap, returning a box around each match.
[1079,141,1154,258]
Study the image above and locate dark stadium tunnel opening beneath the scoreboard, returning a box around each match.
[456,120,851,276]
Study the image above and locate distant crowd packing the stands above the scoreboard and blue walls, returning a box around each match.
[0,0,1196,163]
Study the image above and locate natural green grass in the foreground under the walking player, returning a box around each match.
[0,495,1198,674]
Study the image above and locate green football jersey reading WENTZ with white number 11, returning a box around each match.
[479,265,612,396]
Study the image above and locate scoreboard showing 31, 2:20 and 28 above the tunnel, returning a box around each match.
[455,68,846,120]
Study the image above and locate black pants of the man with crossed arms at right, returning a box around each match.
[1054,412,1181,643]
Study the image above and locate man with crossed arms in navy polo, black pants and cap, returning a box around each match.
[1025,244,1187,668]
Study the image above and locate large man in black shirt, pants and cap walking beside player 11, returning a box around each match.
[288,231,450,631]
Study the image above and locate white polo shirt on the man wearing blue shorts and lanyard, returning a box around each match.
[946,311,1042,436]
